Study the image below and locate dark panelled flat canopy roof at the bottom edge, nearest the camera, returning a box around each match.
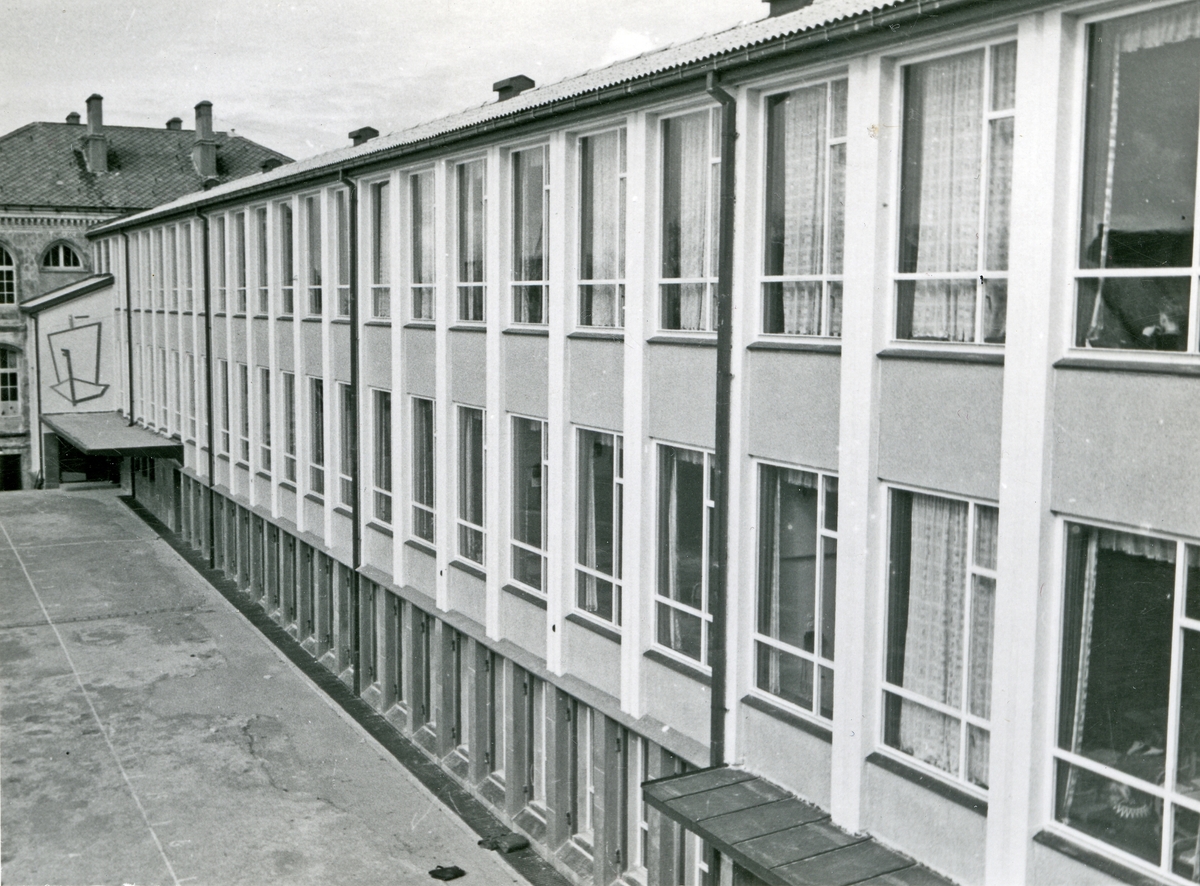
[642,766,950,886]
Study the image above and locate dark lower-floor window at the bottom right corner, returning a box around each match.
[1055,523,1200,882]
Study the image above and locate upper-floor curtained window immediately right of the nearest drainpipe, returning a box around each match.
[762,80,846,336]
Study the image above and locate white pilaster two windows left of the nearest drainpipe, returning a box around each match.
[546,131,576,674]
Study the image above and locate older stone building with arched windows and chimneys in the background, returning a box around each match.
[0,95,289,489]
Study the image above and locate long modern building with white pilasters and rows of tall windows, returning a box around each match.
[72,0,1200,886]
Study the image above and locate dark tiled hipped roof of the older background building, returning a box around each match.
[0,122,290,211]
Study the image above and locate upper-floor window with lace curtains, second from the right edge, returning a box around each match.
[895,42,1016,343]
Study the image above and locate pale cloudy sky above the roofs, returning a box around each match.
[0,0,767,158]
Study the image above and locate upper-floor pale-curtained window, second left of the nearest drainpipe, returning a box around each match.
[580,128,626,328]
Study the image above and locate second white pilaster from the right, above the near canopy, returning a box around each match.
[830,55,899,831]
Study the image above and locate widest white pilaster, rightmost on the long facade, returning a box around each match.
[985,12,1078,884]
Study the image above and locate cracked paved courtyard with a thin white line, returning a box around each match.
[0,490,524,886]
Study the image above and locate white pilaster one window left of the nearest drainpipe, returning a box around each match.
[620,112,656,717]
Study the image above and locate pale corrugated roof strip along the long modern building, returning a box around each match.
[91,0,906,227]
